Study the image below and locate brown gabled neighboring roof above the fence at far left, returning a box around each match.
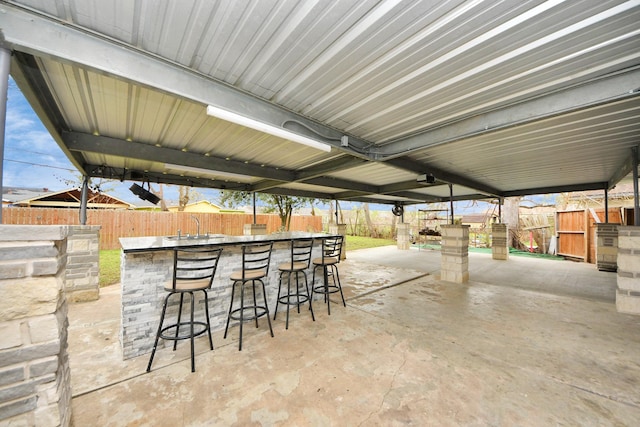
[2,187,133,209]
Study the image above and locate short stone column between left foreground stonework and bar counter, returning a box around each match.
[65,225,100,303]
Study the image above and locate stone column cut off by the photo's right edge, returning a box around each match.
[616,225,640,315]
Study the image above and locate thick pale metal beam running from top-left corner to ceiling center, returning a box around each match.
[0,4,368,156]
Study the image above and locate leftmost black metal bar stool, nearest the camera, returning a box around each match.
[147,248,222,372]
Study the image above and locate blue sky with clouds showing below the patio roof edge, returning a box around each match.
[3,79,500,214]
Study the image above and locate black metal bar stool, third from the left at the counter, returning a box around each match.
[273,239,316,329]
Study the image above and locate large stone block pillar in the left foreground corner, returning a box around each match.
[0,225,71,427]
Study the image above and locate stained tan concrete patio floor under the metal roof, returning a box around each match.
[69,247,640,426]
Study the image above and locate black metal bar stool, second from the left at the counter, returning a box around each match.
[224,242,273,351]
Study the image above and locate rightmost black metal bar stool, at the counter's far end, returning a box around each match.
[311,236,347,315]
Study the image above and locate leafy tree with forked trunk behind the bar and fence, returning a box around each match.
[220,190,314,231]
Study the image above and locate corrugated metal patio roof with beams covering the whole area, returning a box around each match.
[0,0,640,204]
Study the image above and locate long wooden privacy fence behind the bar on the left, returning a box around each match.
[2,207,322,249]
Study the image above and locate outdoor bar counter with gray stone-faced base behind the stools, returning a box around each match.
[120,232,333,359]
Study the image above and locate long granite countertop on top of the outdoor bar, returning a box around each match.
[119,231,332,253]
